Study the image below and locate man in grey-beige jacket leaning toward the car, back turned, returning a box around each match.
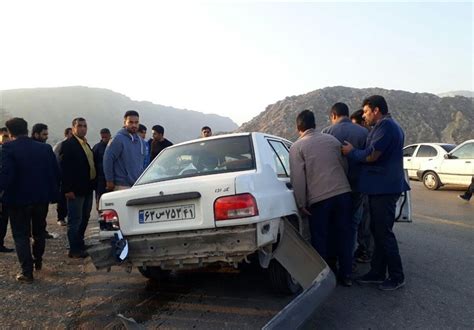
[290,110,353,286]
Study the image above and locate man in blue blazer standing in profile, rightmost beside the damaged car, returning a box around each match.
[342,95,410,290]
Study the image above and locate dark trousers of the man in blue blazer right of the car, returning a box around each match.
[369,194,405,281]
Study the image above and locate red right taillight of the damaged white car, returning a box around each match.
[214,194,258,221]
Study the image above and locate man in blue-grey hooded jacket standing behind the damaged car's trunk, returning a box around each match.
[104,110,146,191]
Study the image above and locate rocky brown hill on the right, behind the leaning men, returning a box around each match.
[238,86,474,144]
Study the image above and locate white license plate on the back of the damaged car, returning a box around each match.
[138,204,196,223]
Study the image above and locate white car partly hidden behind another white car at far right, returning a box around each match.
[403,143,456,179]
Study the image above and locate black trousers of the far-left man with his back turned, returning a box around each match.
[9,204,49,275]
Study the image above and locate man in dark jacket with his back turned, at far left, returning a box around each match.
[0,118,59,283]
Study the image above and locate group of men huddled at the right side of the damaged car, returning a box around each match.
[290,95,410,290]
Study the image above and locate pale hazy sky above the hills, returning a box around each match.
[0,0,474,124]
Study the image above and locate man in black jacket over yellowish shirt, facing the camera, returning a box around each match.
[60,118,96,258]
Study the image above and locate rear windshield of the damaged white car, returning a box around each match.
[136,136,255,185]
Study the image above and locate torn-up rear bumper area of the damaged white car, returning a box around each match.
[88,224,262,269]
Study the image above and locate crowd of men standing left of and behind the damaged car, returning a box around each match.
[0,110,212,283]
